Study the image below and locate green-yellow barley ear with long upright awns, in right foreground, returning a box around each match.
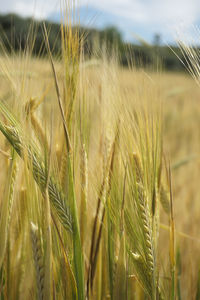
[124,111,161,300]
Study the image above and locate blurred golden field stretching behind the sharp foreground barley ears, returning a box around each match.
[0,49,200,299]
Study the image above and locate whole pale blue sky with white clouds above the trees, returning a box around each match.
[0,0,200,44]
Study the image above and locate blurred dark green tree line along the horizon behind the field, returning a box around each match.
[0,14,188,71]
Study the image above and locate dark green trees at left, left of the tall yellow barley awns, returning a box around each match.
[0,14,61,56]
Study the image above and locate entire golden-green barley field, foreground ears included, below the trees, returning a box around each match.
[0,20,200,300]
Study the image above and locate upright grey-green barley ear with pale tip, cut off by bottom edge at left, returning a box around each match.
[31,223,44,300]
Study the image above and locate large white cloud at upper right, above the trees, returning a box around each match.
[80,0,200,42]
